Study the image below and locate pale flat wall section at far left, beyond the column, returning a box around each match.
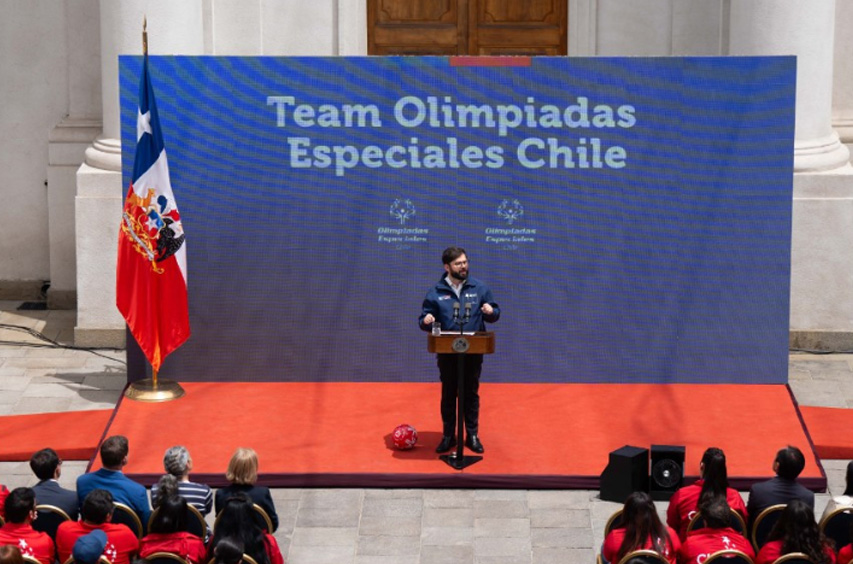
[0,0,68,297]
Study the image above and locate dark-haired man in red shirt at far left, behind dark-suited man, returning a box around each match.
[0,488,56,564]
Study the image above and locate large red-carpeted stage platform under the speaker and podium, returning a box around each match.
[75,382,826,490]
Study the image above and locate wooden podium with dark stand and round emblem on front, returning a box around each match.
[427,331,495,470]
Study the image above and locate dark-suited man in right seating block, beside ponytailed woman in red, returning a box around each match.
[746,446,814,531]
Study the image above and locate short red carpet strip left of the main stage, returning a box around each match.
[0,409,113,462]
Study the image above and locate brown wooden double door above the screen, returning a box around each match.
[367,0,568,55]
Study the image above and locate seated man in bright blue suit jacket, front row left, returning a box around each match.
[77,435,151,529]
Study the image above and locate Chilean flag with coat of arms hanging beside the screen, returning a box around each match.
[116,56,190,373]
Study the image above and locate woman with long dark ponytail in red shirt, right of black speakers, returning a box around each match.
[666,447,746,541]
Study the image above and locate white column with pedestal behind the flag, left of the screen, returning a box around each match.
[74,0,204,347]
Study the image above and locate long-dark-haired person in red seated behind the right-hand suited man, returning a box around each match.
[755,499,835,564]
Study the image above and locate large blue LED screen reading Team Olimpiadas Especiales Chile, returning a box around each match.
[121,56,795,383]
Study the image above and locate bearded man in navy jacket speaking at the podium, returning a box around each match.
[418,247,501,453]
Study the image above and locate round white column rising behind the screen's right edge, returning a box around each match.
[729,0,850,172]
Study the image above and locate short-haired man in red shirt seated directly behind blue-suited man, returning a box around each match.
[56,490,139,564]
